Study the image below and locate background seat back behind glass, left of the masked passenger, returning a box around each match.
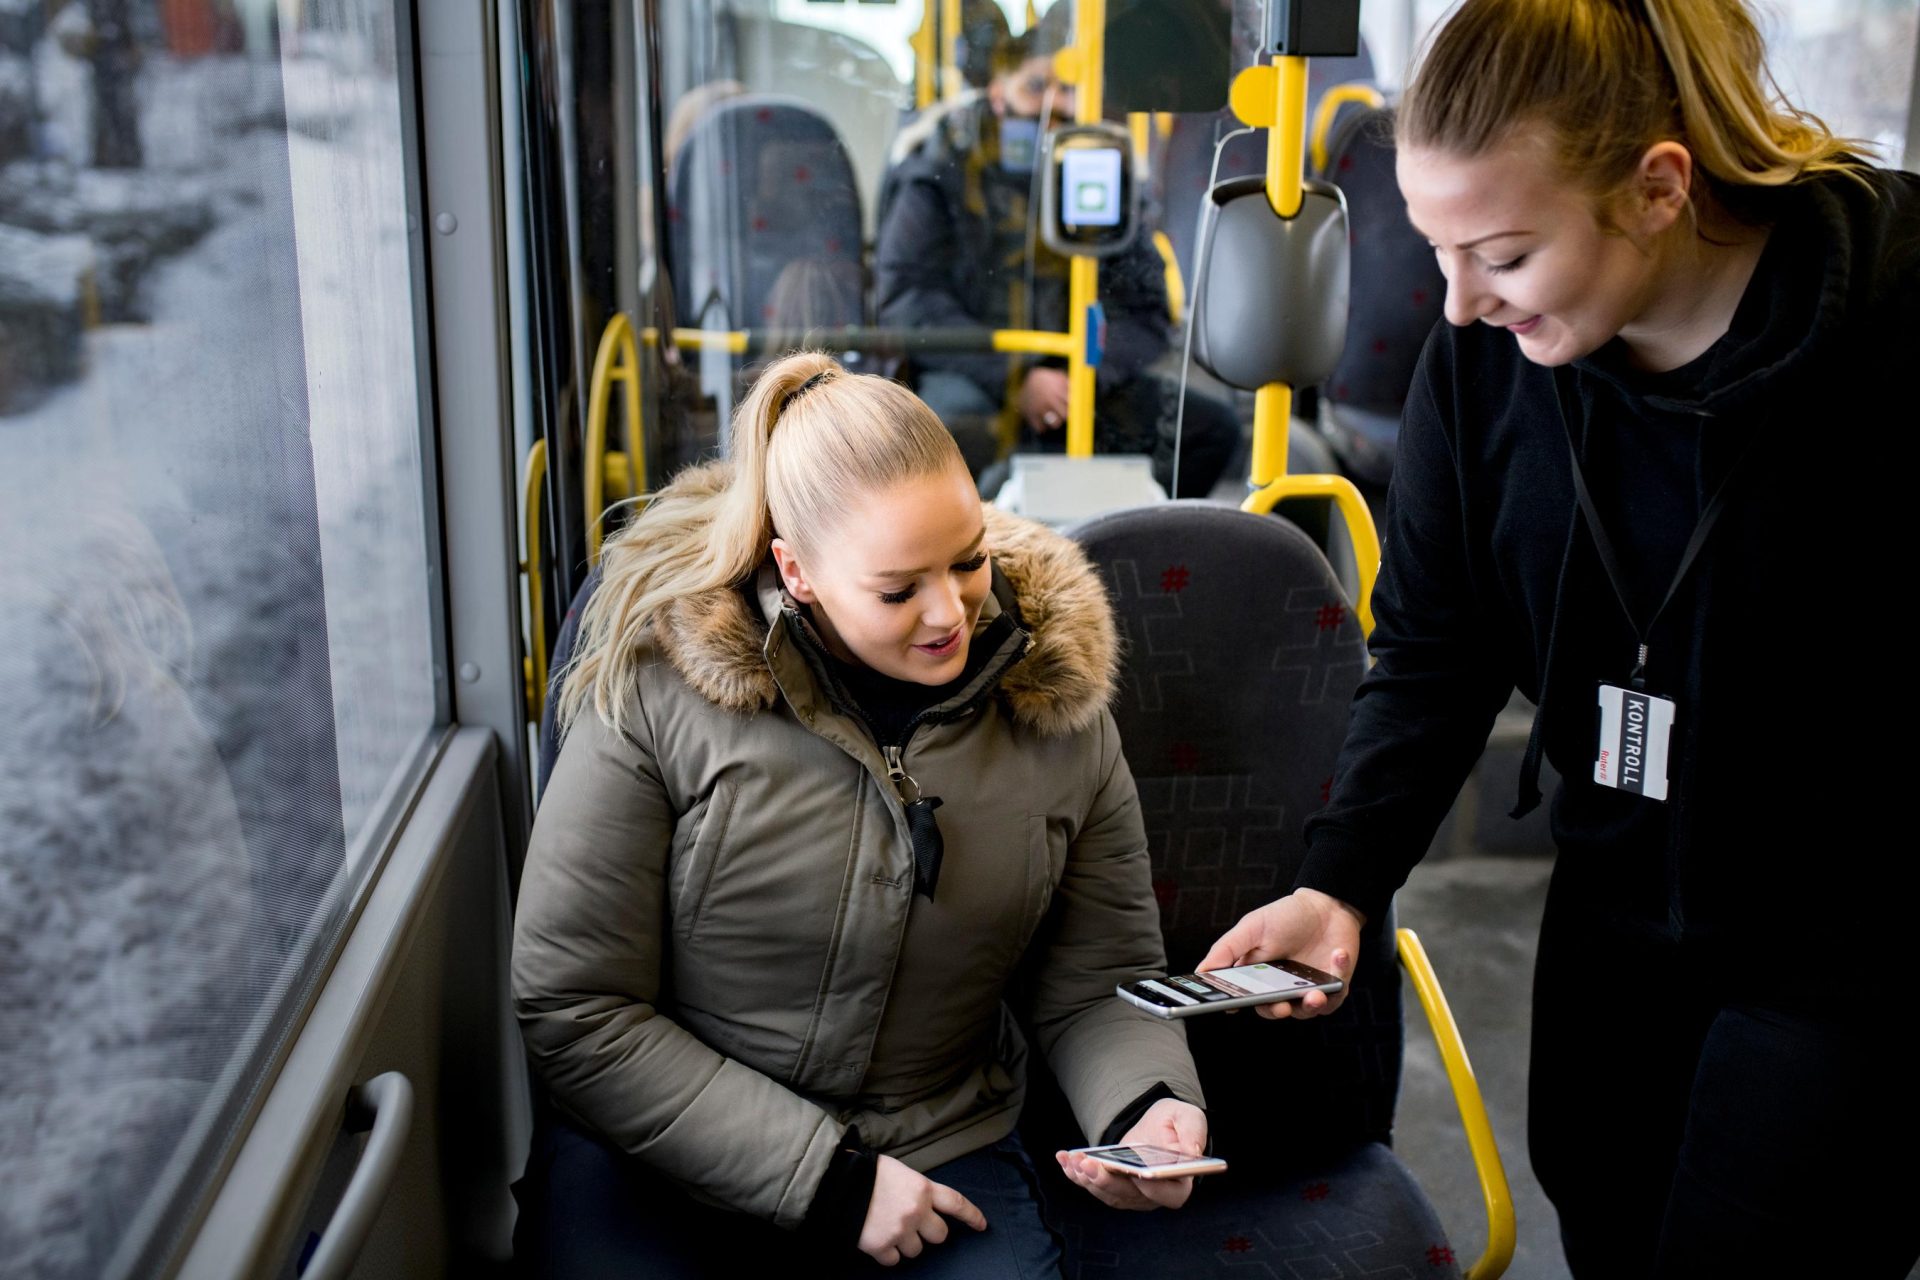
[668,94,866,330]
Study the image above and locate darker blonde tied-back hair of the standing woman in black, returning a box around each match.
[1398,0,1866,198]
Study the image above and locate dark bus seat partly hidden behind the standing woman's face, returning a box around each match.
[1319,106,1446,487]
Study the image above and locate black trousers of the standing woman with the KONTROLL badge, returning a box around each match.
[1528,858,1920,1280]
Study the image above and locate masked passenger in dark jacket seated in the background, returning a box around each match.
[876,2,1240,497]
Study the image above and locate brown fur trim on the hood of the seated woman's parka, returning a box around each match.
[653,462,1119,735]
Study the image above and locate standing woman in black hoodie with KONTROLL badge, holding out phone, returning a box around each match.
[1206,0,1920,1276]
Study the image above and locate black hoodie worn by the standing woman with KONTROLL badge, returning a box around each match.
[1298,171,1920,950]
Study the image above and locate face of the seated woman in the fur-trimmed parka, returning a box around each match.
[774,466,993,685]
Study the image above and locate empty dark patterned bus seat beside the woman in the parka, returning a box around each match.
[1023,503,1459,1276]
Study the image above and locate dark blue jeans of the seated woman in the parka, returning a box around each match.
[513,1117,1060,1280]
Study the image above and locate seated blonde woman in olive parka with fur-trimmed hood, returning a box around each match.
[513,355,1206,1276]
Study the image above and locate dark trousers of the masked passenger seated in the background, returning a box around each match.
[918,370,1240,497]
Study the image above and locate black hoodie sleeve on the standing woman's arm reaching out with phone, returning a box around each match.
[1294,333,1513,919]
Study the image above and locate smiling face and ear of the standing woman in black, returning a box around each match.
[1396,130,1686,365]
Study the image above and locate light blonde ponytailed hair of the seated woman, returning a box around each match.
[559,351,966,729]
